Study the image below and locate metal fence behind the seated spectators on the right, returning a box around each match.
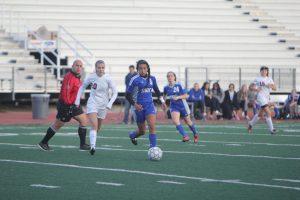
[185,67,300,93]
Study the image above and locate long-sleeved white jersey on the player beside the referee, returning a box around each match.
[75,73,118,110]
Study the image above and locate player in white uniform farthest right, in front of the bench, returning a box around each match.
[248,66,276,134]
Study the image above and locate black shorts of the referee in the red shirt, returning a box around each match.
[56,101,83,122]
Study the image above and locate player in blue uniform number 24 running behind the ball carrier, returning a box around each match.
[164,72,199,143]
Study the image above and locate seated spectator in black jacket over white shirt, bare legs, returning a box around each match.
[222,83,240,120]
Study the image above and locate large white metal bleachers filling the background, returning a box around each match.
[0,0,300,96]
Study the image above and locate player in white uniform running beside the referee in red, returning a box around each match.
[75,60,118,155]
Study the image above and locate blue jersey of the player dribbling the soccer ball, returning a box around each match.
[127,74,159,104]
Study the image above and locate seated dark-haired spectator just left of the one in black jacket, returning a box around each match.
[211,82,224,118]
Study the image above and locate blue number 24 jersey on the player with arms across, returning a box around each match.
[164,83,187,107]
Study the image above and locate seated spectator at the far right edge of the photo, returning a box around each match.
[284,89,299,119]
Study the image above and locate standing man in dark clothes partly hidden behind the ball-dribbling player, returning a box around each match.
[123,65,137,124]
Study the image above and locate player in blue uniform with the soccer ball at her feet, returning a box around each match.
[126,60,166,148]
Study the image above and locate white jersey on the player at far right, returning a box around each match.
[254,76,274,106]
